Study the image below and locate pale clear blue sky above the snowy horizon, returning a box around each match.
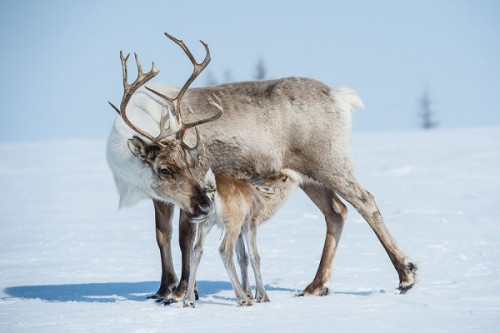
[0,0,500,142]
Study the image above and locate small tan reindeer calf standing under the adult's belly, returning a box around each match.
[184,169,299,307]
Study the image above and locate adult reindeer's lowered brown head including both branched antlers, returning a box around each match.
[109,33,223,215]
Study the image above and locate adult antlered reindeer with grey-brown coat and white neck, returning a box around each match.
[107,33,417,303]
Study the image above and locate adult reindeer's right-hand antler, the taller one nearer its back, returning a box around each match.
[146,32,224,156]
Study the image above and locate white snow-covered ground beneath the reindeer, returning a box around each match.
[0,127,500,332]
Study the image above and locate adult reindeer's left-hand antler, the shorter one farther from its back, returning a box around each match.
[108,51,160,143]
